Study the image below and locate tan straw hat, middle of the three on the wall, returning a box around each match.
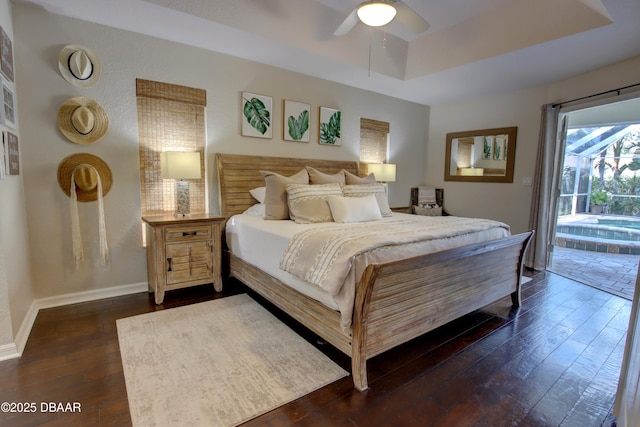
[58,96,109,144]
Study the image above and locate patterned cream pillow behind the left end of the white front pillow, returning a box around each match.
[287,182,342,224]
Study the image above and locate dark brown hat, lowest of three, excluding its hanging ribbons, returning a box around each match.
[58,153,113,202]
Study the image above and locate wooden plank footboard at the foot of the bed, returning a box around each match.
[352,232,533,390]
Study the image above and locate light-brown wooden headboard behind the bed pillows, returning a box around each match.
[216,153,358,219]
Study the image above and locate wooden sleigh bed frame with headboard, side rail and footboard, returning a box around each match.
[216,154,533,391]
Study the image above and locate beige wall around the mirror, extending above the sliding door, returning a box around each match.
[426,57,640,233]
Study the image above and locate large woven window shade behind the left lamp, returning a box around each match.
[136,79,206,215]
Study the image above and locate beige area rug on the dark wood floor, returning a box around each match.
[117,294,348,427]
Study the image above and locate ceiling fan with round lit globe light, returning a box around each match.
[333,0,429,36]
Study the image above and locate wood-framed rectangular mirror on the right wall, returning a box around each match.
[444,127,518,182]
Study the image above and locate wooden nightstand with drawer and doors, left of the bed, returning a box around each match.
[142,214,224,304]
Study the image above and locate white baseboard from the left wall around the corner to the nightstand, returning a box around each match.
[5,282,148,360]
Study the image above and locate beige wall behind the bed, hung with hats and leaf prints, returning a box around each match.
[13,4,429,298]
